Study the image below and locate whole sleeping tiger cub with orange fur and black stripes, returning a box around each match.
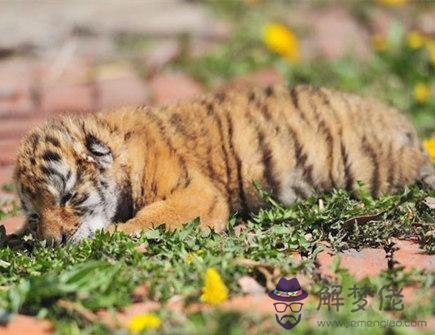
[15,86,435,242]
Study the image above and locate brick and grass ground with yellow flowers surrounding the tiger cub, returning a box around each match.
[0,0,435,334]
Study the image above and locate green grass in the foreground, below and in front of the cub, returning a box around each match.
[0,186,435,334]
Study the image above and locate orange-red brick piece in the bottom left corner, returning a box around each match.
[0,315,54,335]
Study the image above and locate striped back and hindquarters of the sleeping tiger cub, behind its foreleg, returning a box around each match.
[152,86,427,211]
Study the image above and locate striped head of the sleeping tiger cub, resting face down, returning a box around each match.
[14,117,131,243]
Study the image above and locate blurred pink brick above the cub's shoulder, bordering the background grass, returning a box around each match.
[149,73,203,104]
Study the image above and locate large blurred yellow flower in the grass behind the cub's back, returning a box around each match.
[263,23,301,63]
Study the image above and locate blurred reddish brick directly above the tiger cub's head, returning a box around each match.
[41,84,96,113]
